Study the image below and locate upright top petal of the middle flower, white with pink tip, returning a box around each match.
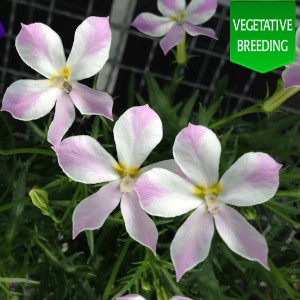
[114,105,163,168]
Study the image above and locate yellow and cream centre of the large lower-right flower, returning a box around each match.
[194,182,222,215]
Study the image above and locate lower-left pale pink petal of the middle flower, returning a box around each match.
[73,180,121,239]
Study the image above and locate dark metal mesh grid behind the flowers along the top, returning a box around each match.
[0,0,299,109]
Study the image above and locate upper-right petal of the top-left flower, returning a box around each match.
[67,17,111,81]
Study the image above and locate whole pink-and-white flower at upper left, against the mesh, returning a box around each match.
[1,17,113,149]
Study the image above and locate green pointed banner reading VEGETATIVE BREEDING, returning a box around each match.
[230,0,296,73]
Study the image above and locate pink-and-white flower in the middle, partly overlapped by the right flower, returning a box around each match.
[57,105,178,253]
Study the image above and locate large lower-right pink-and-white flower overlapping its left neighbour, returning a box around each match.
[134,124,281,281]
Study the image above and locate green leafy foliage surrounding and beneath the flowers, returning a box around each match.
[0,67,300,300]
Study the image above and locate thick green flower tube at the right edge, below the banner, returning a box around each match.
[262,87,300,113]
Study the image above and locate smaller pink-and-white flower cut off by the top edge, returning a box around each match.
[132,0,217,55]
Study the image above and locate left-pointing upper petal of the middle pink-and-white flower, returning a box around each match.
[56,135,120,184]
